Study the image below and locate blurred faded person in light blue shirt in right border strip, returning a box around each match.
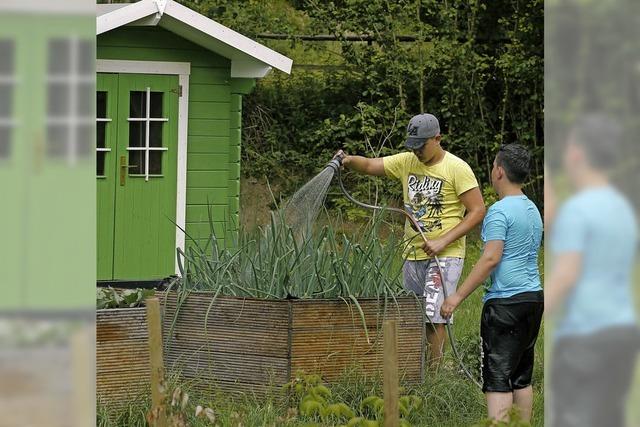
[545,114,639,427]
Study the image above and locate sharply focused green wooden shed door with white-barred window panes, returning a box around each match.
[97,74,178,280]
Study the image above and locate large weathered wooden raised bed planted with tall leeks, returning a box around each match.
[163,293,425,394]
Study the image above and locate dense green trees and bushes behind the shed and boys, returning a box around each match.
[178,0,544,210]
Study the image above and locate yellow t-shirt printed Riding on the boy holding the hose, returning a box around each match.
[382,151,478,260]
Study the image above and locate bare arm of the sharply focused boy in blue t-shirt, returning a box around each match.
[440,240,504,319]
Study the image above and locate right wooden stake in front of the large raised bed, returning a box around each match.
[383,320,400,427]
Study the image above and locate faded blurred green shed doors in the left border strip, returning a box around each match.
[0,15,96,312]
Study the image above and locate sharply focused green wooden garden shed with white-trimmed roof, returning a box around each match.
[96,0,292,281]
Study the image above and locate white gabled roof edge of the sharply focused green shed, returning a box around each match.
[96,0,293,78]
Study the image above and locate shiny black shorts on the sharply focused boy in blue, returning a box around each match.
[480,291,544,392]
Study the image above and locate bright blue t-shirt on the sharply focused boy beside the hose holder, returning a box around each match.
[481,195,542,302]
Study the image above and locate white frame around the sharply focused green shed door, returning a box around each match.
[96,59,191,275]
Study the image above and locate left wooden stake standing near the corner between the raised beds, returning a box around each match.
[146,298,167,427]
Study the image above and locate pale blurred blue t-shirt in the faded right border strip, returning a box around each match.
[551,186,638,337]
